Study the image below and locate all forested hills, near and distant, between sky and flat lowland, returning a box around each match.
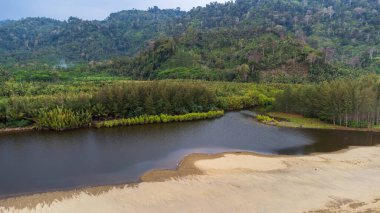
[0,0,380,81]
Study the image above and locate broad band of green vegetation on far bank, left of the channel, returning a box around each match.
[0,78,282,130]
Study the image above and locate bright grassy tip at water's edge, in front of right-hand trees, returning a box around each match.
[268,112,336,129]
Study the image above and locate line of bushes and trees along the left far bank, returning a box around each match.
[0,81,217,129]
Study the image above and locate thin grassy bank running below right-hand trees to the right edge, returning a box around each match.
[263,112,380,132]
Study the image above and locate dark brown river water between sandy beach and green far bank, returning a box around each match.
[0,111,380,197]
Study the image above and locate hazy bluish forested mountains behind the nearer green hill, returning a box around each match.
[0,0,380,75]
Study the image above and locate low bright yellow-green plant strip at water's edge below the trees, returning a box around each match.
[95,111,224,128]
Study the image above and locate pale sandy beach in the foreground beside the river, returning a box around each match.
[0,146,380,212]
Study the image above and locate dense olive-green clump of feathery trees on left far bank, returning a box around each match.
[90,81,216,117]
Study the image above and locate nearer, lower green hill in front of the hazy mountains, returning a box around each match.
[95,29,350,83]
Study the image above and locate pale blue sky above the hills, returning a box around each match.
[0,0,227,20]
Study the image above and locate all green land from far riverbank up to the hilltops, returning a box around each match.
[0,0,380,130]
